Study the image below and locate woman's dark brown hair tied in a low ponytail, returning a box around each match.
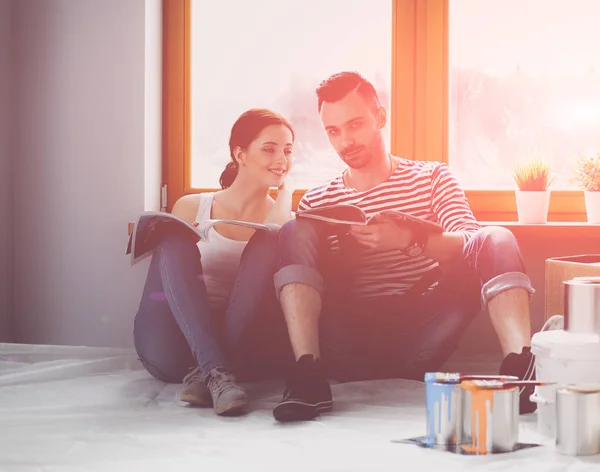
[219,108,295,189]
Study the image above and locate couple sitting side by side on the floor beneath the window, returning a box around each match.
[134,72,534,421]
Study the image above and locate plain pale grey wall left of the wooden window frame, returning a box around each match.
[12,0,160,347]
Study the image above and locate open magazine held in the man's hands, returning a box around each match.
[296,203,443,233]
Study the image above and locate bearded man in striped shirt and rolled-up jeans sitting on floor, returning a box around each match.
[273,72,534,421]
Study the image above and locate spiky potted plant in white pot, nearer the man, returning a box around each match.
[513,158,553,224]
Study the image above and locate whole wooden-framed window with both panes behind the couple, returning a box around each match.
[163,0,600,221]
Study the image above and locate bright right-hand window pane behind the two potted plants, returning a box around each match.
[449,0,600,190]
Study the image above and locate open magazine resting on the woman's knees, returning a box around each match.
[125,211,271,265]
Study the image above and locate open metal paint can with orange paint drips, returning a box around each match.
[460,380,519,454]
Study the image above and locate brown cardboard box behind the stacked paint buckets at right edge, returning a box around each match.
[545,254,600,319]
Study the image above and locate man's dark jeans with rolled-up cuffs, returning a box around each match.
[275,219,534,380]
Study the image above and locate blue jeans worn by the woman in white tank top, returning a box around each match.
[133,227,293,383]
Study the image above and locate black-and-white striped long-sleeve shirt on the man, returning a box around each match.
[298,159,480,298]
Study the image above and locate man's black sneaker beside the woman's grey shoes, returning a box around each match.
[273,354,333,422]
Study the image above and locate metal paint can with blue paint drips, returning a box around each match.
[425,372,461,445]
